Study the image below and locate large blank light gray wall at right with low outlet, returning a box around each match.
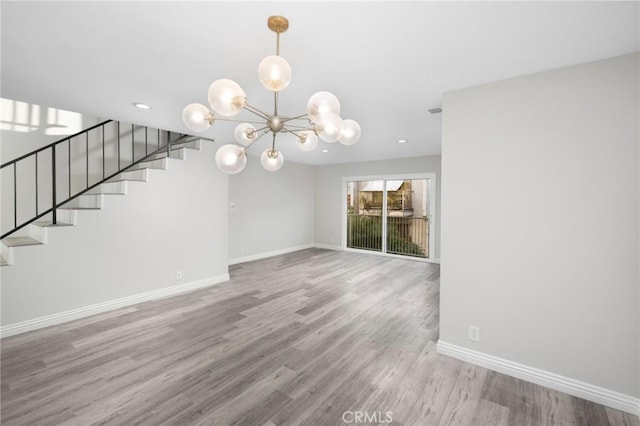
[440,54,640,397]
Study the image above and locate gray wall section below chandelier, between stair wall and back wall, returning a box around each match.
[229,156,315,262]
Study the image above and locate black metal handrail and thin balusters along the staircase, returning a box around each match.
[0,120,200,239]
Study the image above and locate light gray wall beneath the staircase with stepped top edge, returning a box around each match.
[0,141,228,326]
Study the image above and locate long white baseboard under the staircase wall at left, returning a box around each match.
[0,274,229,338]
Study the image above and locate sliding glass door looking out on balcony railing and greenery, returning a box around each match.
[343,176,433,259]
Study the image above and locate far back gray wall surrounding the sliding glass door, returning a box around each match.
[315,156,441,259]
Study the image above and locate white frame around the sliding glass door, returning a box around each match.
[340,172,437,263]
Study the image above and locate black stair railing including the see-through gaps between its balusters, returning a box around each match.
[0,120,195,239]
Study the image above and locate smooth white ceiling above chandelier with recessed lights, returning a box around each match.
[1,1,640,164]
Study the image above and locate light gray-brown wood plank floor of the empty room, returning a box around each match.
[1,249,640,426]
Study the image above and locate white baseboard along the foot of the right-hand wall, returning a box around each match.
[437,340,640,416]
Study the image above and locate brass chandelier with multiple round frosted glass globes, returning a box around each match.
[182,16,360,174]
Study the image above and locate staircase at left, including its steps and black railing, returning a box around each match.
[0,120,210,267]
